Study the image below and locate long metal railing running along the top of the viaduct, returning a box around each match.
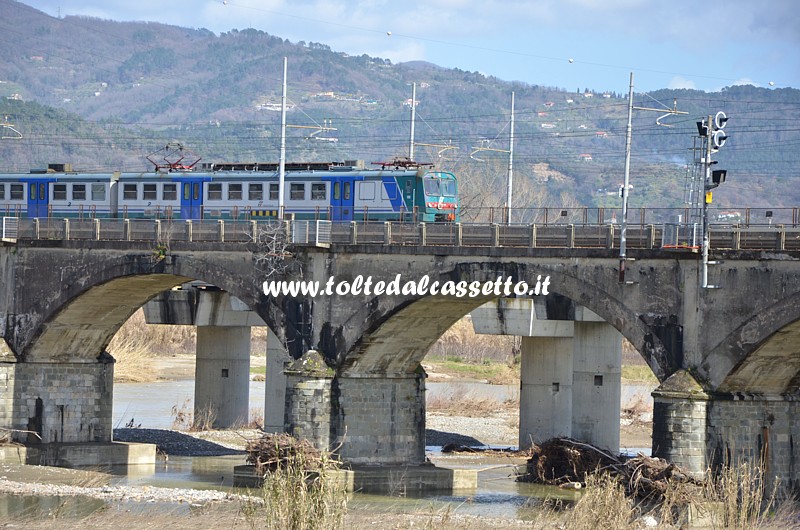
[3,217,800,250]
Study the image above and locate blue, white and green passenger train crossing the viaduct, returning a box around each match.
[0,155,459,222]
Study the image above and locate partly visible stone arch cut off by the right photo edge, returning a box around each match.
[701,286,800,394]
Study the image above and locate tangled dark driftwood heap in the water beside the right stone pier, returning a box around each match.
[517,438,701,502]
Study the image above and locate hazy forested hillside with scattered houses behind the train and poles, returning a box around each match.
[0,0,800,207]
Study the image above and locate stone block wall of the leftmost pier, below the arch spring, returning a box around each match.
[0,362,114,443]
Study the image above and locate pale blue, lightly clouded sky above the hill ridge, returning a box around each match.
[10,0,800,93]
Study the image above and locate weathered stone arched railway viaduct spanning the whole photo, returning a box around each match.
[0,219,800,485]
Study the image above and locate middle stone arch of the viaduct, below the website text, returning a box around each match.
[339,262,679,380]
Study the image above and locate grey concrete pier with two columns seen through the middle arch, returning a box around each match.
[472,299,622,451]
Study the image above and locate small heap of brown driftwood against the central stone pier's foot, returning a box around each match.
[245,433,324,473]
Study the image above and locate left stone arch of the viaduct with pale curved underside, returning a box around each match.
[12,246,285,361]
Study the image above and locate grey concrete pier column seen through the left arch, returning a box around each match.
[194,326,250,429]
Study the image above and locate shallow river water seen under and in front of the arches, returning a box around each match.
[0,380,652,519]
